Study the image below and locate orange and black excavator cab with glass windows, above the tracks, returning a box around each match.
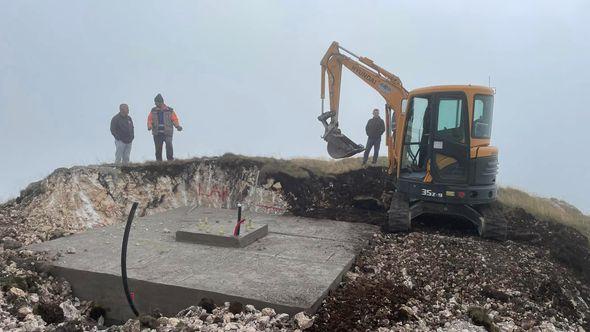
[399,85,497,195]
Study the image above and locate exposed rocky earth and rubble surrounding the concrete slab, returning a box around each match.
[0,156,590,331]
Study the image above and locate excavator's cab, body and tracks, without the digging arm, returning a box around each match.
[384,85,506,240]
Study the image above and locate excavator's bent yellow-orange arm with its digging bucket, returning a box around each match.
[318,42,408,170]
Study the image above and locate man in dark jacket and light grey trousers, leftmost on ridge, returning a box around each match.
[111,104,134,165]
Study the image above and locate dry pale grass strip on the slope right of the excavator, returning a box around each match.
[498,187,590,241]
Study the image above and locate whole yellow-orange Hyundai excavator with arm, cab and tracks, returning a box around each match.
[318,42,507,241]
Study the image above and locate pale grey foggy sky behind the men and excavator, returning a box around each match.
[0,0,590,212]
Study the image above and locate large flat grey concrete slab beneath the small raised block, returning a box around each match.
[29,207,377,321]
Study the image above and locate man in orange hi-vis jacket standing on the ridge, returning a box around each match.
[148,93,182,161]
